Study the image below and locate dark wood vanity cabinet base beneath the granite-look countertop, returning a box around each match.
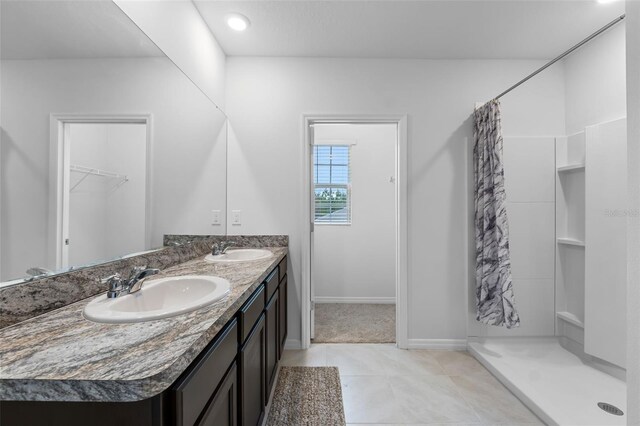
[0,257,288,426]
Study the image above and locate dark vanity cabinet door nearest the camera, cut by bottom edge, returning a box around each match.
[198,362,238,426]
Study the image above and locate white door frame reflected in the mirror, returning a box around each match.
[48,113,153,270]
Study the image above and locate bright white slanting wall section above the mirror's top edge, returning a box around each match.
[114,0,226,110]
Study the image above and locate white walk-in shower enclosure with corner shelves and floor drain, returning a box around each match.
[468,13,629,425]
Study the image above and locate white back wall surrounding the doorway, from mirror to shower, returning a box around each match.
[226,57,565,342]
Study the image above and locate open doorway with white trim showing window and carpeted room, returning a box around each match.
[301,117,407,348]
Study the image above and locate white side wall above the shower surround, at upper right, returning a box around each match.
[563,22,627,135]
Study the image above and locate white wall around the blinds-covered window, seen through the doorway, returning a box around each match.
[312,124,398,303]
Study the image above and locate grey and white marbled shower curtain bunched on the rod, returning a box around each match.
[473,100,520,328]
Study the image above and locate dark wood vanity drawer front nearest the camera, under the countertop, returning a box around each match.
[173,319,238,426]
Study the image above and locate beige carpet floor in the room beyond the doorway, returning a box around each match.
[313,303,396,343]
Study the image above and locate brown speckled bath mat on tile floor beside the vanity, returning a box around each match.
[267,367,346,426]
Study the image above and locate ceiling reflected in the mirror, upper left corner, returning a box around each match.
[0,0,164,59]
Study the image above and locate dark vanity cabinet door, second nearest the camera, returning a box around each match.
[239,314,266,426]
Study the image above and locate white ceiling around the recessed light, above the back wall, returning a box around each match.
[194,0,624,59]
